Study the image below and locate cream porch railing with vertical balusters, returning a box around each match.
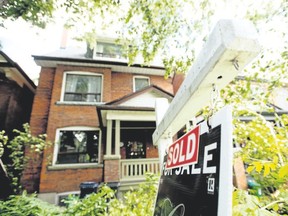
[120,158,160,181]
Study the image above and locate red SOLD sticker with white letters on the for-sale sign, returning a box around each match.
[166,126,200,169]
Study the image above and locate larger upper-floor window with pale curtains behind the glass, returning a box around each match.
[63,72,102,102]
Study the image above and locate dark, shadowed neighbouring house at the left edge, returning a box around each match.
[0,51,36,199]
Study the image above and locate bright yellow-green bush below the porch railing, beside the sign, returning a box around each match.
[64,173,158,216]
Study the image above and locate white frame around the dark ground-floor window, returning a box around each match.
[52,126,102,167]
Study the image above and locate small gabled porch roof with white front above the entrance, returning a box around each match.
[96,85,174,127]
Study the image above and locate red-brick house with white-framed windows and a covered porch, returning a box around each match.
[23,40,173,204]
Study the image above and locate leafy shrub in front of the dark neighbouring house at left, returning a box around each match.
[0,123,49,193]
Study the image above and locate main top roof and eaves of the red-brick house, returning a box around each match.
[33,47,165,76]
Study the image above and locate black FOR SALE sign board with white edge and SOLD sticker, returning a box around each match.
[154,107,233,216]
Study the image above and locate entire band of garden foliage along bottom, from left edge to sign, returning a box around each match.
[0,173,158,216]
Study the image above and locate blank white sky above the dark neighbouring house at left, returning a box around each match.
[0,20,63,81]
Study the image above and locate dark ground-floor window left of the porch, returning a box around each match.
[54,128,101,164]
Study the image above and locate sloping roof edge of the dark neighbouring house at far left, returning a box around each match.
[0,51,36,93]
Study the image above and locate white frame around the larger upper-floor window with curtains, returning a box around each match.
[60,71,104,104]
